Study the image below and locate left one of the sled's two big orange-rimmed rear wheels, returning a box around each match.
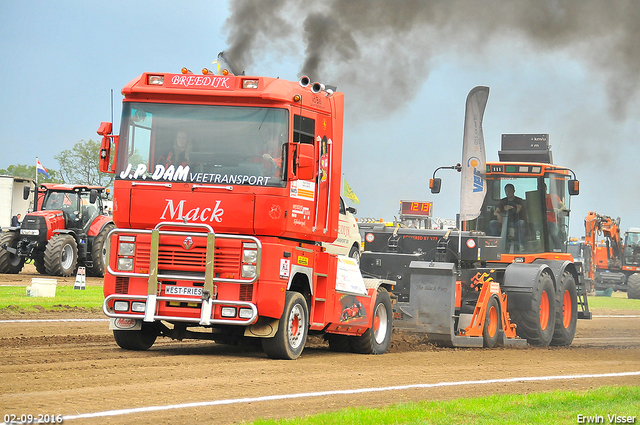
[509,273,556,347]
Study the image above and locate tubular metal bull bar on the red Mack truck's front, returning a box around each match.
[102,222,262,326]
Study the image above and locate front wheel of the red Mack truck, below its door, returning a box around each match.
[262,291,309,360]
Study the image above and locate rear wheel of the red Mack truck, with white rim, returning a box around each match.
[351,287,393,354]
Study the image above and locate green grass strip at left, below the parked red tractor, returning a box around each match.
[0,286,104,312]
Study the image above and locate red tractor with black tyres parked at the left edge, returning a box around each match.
[0,183,115,277]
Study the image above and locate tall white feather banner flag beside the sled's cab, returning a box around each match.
[460,86,489,221]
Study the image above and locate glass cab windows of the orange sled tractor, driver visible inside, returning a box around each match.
[476,175,570,254]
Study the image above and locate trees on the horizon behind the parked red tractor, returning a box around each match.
[0,139,115,187]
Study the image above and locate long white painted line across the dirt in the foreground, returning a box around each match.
[52,371,640,421]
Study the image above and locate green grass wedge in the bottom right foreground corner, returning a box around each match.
[253,387,640,425]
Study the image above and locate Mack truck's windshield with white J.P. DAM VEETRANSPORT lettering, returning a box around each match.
[116,102,288,187]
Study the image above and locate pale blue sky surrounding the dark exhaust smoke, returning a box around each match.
[0,0,640,236]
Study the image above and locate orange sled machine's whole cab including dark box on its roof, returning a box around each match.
[467,134,579,255]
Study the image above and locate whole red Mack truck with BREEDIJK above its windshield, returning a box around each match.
[98,64,392,359]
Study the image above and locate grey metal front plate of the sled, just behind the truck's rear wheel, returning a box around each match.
[393,261,483,347]
